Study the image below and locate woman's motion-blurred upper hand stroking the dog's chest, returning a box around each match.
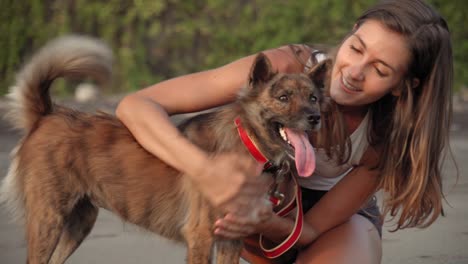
[197,153,272,230]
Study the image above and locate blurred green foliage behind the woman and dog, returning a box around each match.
[0,0,468,95]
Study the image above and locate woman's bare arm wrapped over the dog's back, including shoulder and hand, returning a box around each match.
[116,47,305,217]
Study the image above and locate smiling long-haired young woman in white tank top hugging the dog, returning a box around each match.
[117,0,453,263]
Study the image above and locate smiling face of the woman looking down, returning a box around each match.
[330,20,410,108]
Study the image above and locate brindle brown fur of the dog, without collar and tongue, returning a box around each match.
[1,36,330,264]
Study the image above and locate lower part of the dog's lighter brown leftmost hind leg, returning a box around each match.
[26,206,64,264]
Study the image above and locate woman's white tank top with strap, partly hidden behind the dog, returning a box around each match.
[298,51,369,191]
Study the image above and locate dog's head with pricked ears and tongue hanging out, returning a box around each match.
[239,53,332,176]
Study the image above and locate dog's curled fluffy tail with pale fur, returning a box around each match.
[7,35,112,131]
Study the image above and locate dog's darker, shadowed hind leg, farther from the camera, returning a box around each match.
[50,198,99,264]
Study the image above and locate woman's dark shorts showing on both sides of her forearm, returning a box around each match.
[301,188,382,237]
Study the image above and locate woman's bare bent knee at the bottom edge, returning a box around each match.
[295,214,382,264]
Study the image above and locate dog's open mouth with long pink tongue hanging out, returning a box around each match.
[278,125,315,177]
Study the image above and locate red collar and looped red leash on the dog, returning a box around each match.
[234,117,304,258]
